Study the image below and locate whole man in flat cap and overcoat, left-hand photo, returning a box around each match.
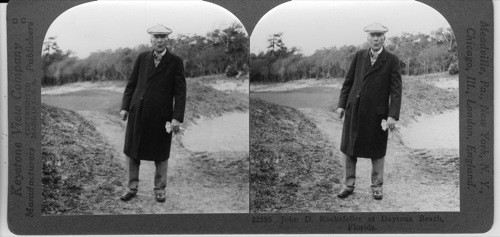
[120,25,186,202]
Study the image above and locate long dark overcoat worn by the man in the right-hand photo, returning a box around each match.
[338,48,402,159]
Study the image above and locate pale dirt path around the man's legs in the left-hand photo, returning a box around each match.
[43,89,249,214]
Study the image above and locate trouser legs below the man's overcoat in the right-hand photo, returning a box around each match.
[344,154,385,191]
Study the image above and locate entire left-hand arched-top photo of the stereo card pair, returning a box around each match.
[40,1,250,215]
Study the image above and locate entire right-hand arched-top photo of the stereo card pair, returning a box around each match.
[250,1,460,213]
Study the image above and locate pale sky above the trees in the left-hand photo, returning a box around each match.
[45,1,243,58]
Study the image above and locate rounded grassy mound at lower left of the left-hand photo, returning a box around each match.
[41,105,124,215]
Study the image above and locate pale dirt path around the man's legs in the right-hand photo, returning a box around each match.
[300,108,460,212]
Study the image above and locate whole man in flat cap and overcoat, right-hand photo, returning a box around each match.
[337,23,402,200]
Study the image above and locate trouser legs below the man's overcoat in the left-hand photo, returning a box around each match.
[127,156,168,194]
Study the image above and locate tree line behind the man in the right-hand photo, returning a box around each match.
[250,27,458,82]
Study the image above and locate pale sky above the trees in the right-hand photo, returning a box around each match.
[250,0,449,55]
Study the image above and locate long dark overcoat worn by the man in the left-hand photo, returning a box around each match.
[121,50,186,161]
